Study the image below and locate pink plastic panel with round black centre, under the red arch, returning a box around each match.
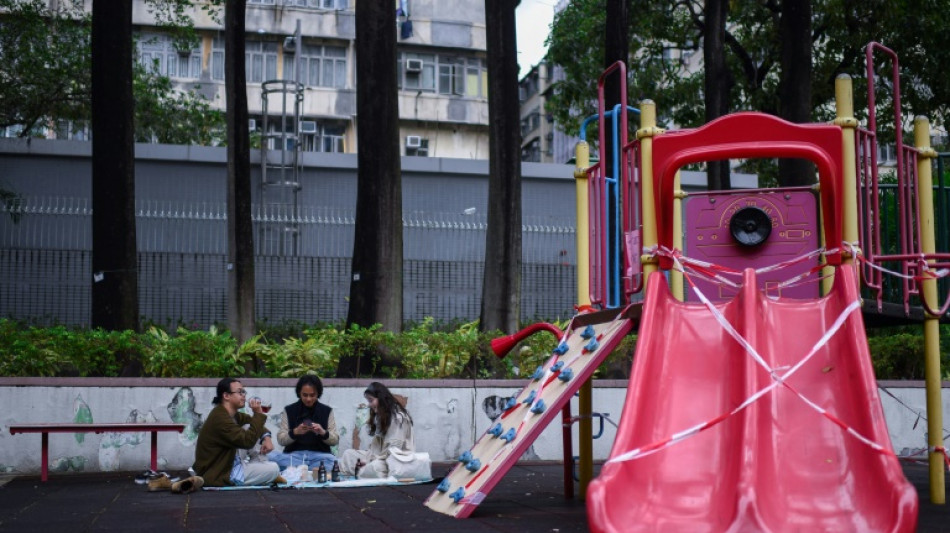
[683,188,820,301]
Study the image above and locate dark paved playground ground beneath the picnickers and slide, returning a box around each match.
[0,464,950,533]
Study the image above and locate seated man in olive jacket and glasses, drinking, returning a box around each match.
[193,378,280,487]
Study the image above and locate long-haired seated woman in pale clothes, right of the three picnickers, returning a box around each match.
[340,381,415,478]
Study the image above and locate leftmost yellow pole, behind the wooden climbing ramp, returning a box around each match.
[574,141,594,499]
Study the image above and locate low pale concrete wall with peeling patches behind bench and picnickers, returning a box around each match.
[0,378,950,474]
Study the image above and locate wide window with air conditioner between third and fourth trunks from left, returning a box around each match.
[398,52,488,98]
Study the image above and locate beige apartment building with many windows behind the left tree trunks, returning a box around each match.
[34,0,488,159]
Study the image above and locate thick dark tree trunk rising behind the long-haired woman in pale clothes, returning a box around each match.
[337,2,403,377]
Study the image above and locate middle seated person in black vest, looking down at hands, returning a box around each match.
[267,374,340,472]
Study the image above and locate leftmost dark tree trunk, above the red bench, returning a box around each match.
[92,0,141,375]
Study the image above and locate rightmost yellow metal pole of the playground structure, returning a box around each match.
[914,117,946,505]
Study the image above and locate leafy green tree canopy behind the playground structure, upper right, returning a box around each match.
[548,0,950,185]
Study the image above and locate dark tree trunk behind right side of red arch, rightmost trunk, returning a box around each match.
[778,0,816,187]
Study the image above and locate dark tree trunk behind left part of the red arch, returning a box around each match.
[703,0,732,190]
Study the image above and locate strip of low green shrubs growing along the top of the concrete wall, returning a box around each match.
[0,318,950,379]
